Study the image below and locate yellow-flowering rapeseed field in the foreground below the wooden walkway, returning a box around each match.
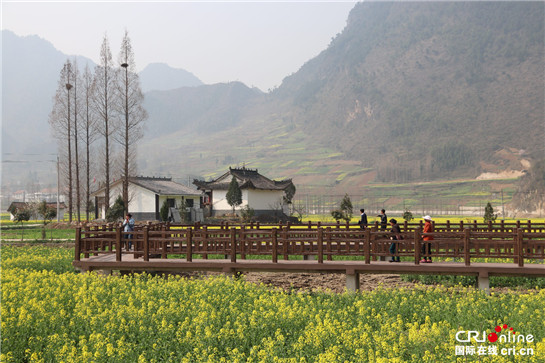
[0,247,545,363]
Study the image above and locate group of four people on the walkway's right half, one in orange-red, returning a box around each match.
[358,208,433,263]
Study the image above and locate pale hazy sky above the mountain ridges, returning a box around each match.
[1,0,356,91]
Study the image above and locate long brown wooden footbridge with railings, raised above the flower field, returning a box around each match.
[73,221,545,290]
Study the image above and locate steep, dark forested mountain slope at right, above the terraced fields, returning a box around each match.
[273,2,545,181]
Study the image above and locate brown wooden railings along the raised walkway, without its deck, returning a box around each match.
[75,223,545,266]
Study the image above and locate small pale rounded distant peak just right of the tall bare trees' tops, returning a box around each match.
[139,63,204,92]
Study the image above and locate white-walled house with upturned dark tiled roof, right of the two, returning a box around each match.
[193,167,293,216]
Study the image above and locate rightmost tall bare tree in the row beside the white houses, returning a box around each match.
[116,31,148,213]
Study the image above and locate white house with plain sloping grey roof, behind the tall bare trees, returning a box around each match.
[91,176,201,220]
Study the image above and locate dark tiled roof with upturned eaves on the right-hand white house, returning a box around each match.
[193,168,293,190]
